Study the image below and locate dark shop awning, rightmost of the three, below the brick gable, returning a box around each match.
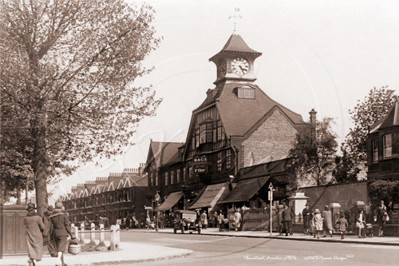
[219,176,270,203]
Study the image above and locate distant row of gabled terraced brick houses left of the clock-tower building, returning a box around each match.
[59,164,152,224]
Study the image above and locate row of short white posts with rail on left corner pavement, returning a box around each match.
[71,223,121,251]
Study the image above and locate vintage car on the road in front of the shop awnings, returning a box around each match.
[173,210,201,234]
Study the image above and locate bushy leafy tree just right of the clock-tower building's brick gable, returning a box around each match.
[289,118,338,186]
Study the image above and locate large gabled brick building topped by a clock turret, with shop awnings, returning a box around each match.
[145,34,310,213]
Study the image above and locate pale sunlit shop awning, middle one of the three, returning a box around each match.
[189,183,228,209]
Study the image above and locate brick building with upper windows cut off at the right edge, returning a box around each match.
[367,102,399,180]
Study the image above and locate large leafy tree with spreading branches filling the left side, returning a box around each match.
[0,0,161,213]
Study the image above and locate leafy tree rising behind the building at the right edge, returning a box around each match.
[342,86,399,163]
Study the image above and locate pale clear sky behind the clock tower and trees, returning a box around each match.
[49,0,399,203]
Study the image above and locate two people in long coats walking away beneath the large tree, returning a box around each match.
[24,202,74,266]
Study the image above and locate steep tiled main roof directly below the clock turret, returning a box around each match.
[216,83,303,136]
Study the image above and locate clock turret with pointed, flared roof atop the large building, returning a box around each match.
[209,33,262,85]
